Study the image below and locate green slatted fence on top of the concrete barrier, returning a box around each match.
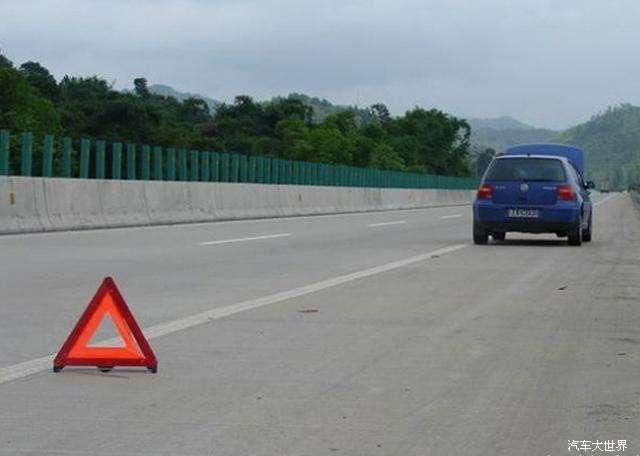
[0,130,477,189]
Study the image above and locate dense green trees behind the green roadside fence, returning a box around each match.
[0,51,471,176]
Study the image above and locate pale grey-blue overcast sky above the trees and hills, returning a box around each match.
[0,0,640,128]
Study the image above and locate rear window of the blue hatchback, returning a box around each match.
[486,158,566,181]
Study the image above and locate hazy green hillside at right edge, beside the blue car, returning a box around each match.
[556,104,640,189]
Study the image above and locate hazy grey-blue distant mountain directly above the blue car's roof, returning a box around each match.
[467,117,558,152]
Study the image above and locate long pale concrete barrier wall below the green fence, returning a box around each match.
[0,176,473,234]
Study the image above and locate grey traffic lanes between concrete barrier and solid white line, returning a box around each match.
[0,203,470,366]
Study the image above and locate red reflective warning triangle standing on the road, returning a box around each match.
[53,277,158,372]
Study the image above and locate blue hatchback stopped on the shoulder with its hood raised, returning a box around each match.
[473,144,594,245]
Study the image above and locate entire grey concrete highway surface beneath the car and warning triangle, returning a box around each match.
[0,194,640,456]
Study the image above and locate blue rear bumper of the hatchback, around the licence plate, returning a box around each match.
[473,202,580,233]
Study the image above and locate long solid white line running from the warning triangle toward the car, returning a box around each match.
[0,244,468,384]
